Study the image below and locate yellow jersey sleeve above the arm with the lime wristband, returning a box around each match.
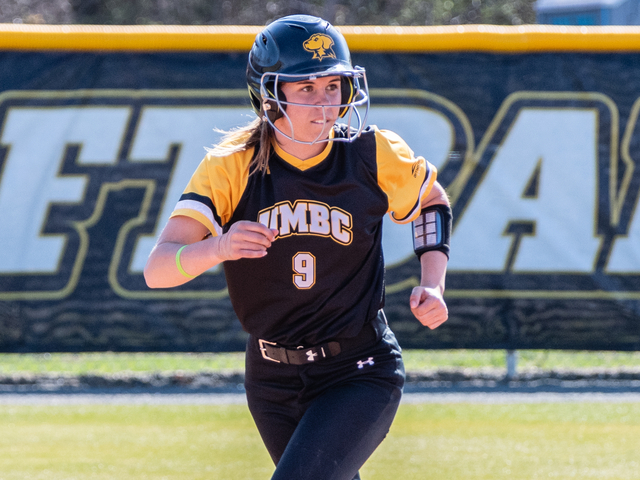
[171,148,254,236]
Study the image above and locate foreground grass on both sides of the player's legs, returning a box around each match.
[0,403,640,480]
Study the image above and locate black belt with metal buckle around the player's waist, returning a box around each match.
[258,319,378,365]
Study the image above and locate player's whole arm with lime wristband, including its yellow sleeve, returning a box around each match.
[144,142,275,288]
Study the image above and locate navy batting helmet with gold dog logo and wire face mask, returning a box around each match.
[247,15,369,144]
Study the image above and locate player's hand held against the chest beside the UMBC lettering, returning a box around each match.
[215,220,277,261]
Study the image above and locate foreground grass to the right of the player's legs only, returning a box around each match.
[363,403,640,480]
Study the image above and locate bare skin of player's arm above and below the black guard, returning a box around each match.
[409,181,450,329]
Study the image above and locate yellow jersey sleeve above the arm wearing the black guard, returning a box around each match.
[375,129,438,223]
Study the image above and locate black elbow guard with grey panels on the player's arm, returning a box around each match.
[411,204,453,258]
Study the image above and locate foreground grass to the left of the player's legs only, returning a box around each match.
[0,405,272,480]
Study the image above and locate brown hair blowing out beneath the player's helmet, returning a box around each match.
[207,117,274,175]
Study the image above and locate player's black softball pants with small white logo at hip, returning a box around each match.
[245,318,405,480]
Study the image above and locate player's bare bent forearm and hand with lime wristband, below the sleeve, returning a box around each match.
[144,215,275,288]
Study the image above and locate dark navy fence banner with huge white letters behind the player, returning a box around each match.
[0,47,640,352]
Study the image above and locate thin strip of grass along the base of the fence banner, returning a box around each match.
[0,350,640,375]
